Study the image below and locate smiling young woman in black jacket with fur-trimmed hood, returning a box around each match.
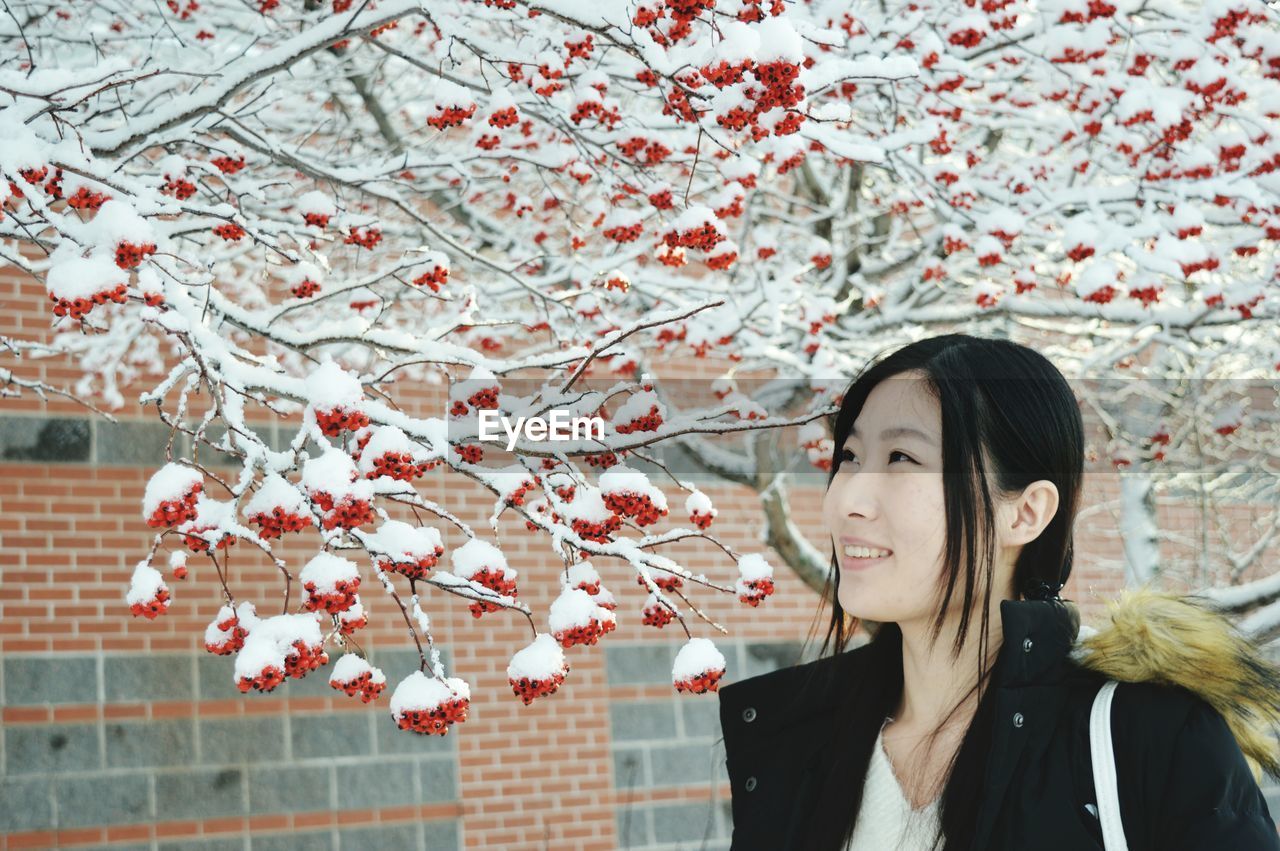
[719,334,1280,851]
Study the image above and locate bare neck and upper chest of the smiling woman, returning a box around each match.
[893,612,1004,731]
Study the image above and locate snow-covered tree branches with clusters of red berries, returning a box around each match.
[0,0,1280,733]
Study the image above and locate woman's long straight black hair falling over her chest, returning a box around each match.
[803,334,1084,851]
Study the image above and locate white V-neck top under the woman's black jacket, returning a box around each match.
[845,718,941,851]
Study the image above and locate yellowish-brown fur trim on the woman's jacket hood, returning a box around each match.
[1071,587,1280,781]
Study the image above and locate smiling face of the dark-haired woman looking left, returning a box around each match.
[822,372,956,624]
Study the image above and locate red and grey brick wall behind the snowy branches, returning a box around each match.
[0,263,1275,851]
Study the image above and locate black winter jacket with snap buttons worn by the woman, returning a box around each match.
[719,591,1280,851]
